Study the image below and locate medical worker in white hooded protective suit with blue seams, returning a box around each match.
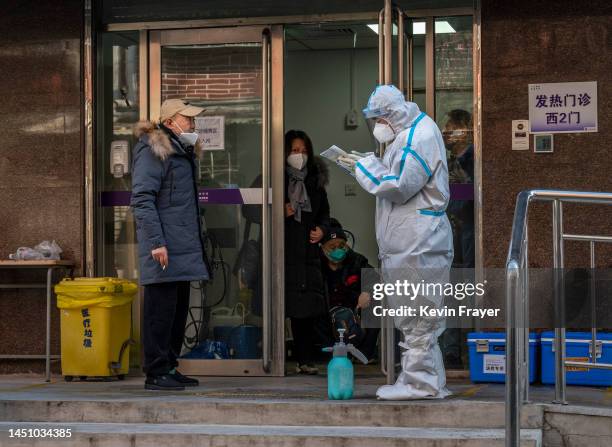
[355,85,453,400]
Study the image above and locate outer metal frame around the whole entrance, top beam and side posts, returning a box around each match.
[87,0,483,296]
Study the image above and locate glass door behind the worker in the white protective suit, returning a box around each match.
[378,0,475,383]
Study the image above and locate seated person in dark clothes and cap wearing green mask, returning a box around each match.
[321,218,380,360]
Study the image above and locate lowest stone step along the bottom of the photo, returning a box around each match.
[0,422,542,447]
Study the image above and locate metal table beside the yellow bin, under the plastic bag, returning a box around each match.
[0,260,74,382]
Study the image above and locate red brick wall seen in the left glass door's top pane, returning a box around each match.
[162,47,261,100]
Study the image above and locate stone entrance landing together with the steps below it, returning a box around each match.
[0,366,612,447]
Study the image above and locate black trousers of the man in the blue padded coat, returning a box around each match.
[142,281,190,376]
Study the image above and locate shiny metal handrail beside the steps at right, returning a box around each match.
[506,189,612,447]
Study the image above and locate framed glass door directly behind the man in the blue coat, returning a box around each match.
[149,27,284,376]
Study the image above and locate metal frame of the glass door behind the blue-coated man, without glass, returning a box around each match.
[146,25,285,376]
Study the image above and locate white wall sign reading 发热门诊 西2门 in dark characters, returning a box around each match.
[529,82,597,133]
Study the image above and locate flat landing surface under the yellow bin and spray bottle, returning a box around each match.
[0,367,612,408]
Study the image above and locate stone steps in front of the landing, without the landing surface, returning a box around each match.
[0,398,544,447]
